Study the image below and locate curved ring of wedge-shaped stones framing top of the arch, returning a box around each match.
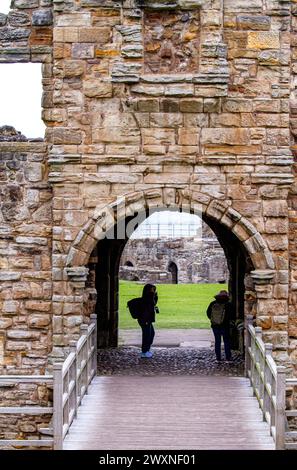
[66,187,275,269]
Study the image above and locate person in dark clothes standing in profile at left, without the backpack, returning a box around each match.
[138,284,159,358]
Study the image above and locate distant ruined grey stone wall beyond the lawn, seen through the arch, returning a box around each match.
[119,224,229,284]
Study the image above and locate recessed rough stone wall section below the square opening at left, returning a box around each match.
[0,127,52,374]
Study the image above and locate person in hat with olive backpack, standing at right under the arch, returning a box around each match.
[207,290,233,362]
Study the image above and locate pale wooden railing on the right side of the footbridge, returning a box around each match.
[245,317,297,450]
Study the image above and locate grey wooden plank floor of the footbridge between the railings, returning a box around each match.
[64,376,274,450]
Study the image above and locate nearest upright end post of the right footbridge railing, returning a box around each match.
[275,366,286,450]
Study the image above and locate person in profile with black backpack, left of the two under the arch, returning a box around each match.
[127,284,159,358]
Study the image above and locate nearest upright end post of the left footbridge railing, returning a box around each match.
[53,362,64,450]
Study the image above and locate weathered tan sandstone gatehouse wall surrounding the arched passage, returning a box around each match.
[0,0,297,437]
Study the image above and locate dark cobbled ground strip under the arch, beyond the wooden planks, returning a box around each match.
[98,346,244,376]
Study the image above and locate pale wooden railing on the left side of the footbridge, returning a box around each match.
[0,315,97,450]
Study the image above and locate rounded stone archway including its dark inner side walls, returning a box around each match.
[56,187,275,347]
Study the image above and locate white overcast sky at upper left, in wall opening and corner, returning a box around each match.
[0,0,45,137]
